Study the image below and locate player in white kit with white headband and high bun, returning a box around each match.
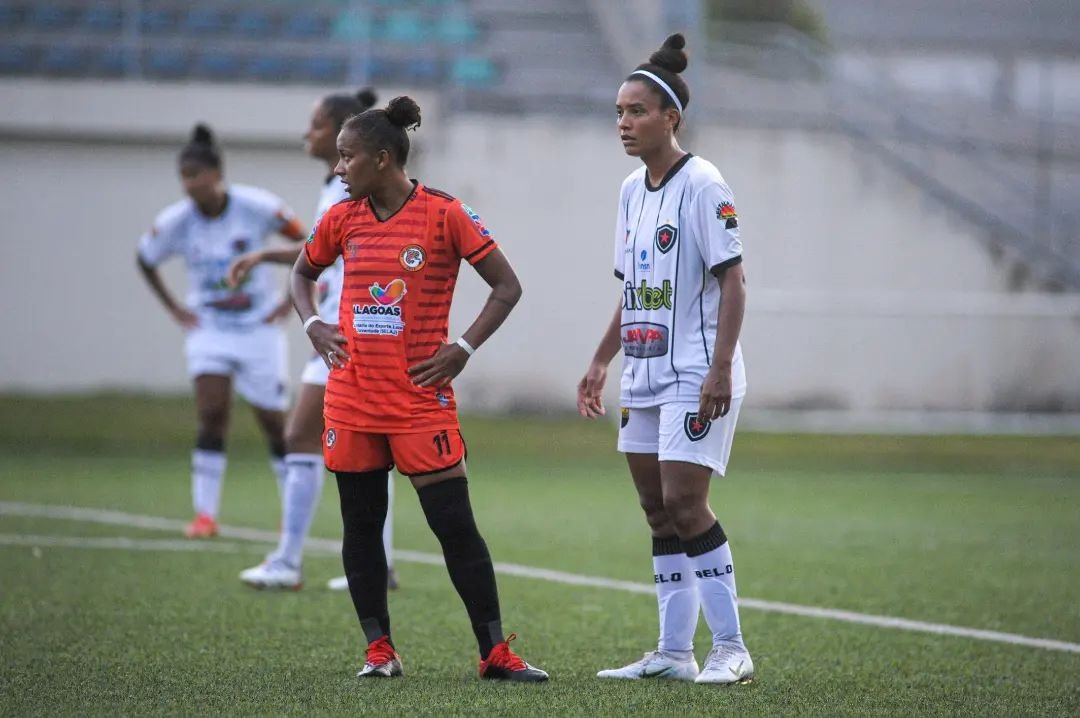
[578,35,754,683]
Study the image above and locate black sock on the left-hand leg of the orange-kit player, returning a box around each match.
[335,471,393,645]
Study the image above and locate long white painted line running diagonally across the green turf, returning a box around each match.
[6,501,1080,653]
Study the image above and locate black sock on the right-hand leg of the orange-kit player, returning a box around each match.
[417,476,504,659]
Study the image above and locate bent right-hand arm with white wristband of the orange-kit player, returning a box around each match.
[408,249,522,387]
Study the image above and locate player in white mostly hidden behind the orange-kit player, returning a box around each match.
[229,89,397,591]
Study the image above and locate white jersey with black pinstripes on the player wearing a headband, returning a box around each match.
[615,154,746,408]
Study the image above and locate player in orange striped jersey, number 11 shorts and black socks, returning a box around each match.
[292,97,548,681]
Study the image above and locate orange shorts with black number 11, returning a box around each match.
[323,428,465,476]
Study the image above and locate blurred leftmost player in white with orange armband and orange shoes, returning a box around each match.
[138,124,305,539]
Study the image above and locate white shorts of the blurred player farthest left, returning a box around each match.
[184,325,288,411]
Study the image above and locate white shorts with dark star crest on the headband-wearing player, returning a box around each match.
[619,396,742,476]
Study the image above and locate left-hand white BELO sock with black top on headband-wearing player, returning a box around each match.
[652,537,701,661]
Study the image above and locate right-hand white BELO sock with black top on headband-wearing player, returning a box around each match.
[684,524,742,646]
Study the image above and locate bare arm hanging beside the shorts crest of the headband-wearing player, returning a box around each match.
[698,263,746,420]
